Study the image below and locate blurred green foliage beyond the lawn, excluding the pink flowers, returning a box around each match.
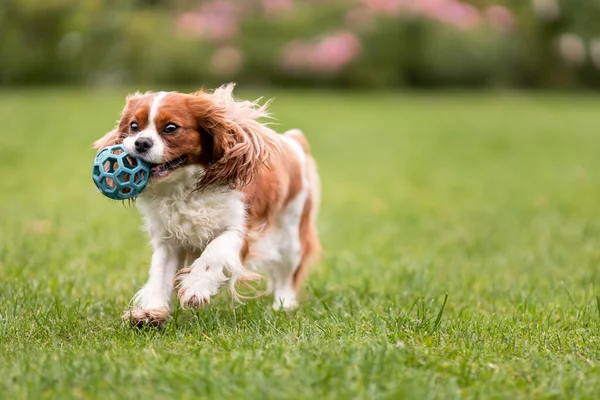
[0,0,600,87]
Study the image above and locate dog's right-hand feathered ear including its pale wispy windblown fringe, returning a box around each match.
[190,84,279,189]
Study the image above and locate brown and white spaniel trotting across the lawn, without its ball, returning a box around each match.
[94,84,321,326]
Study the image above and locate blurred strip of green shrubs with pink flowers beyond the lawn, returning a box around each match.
[0,0,600,88]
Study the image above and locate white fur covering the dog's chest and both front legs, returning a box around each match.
[135,166,246,308]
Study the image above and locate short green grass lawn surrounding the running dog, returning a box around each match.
[0,90,600,399]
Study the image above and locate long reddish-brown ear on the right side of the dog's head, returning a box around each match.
[190,92,269,189]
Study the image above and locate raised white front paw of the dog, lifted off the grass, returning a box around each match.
[175,268,219,308]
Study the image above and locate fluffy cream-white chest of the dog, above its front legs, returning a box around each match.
[138,185,244,250]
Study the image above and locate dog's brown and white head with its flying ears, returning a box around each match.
[94,84,277,188]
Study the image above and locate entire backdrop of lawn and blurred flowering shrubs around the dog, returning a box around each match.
[0,0,600,400]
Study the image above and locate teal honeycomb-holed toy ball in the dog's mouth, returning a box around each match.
[92,144,150,200]
